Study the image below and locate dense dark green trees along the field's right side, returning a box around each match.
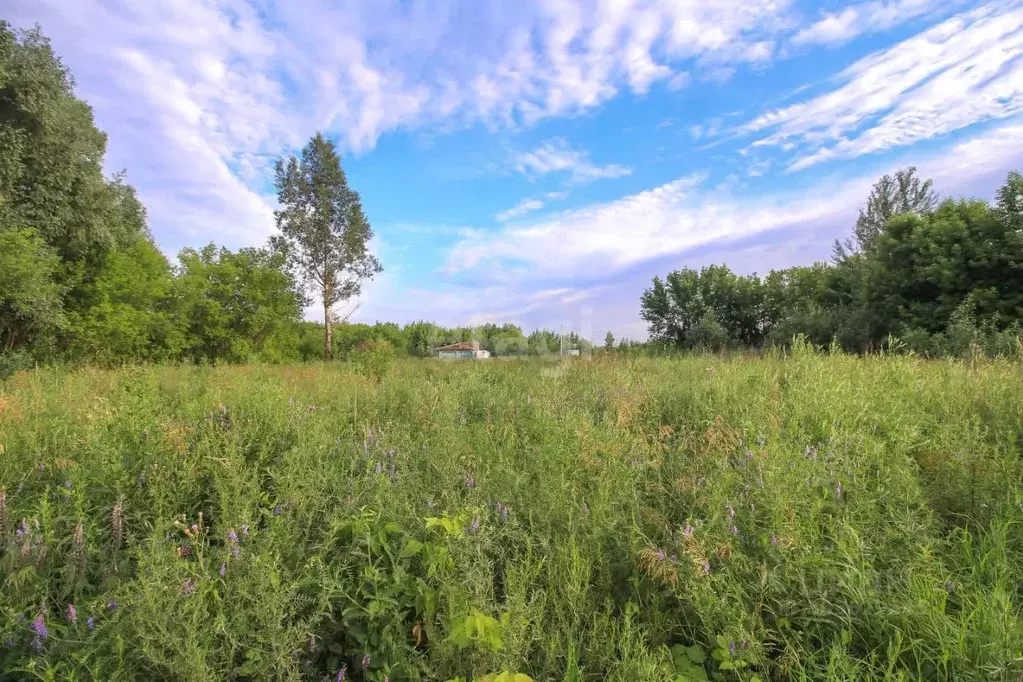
[640,167,1023,356]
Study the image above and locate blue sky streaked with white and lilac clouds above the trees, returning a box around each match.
[4,0,1023,338]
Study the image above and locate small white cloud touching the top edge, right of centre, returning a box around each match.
[792,0,949,45]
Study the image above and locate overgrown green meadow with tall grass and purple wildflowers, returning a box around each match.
[0,349,1023,682]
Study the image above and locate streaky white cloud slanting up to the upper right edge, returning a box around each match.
[743,3,1023,170]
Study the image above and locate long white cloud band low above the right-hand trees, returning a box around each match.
[446,118,1023,280]
